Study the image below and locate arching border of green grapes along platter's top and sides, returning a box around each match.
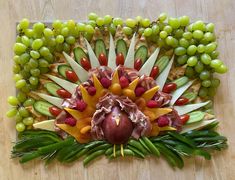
[7,13,227,132]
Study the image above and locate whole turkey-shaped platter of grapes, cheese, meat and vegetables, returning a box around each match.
[6,13,228,168]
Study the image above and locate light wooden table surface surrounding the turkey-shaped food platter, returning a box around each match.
[0,0,235,180]
